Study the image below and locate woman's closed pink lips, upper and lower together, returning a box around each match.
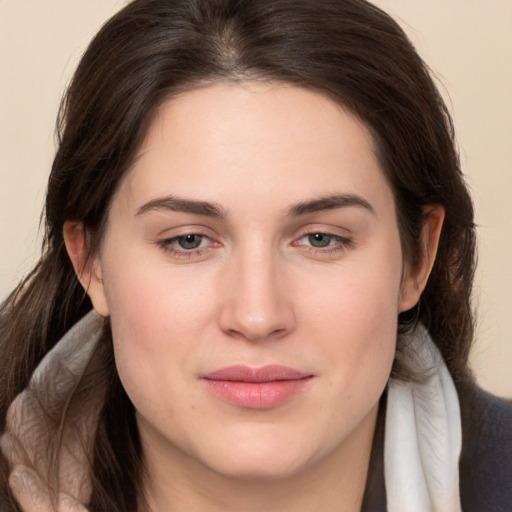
[202,365,313,409]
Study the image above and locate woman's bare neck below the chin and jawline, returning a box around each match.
[139,405,378,512]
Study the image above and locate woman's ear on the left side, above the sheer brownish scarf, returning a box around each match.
[63,221,109,317]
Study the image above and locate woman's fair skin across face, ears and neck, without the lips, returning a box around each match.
[64,83,443,511]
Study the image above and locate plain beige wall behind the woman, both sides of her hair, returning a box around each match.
[0,0,512,397]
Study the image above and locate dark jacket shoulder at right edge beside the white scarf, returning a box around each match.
[458,382,512,512]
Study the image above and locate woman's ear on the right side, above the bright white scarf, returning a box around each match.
[399,205,444,312]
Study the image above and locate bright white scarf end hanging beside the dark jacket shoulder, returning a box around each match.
[384,326,462,512]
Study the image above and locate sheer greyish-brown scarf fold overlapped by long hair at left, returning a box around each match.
[0,311,104,512]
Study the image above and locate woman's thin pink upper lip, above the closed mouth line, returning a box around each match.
[202,364,312,382]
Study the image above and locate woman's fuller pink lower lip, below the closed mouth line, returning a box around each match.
[204,377,311,409]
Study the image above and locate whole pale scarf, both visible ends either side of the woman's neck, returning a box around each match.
[0,312,461,512]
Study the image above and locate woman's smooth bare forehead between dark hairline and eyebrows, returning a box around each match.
[115,82,392,216]
